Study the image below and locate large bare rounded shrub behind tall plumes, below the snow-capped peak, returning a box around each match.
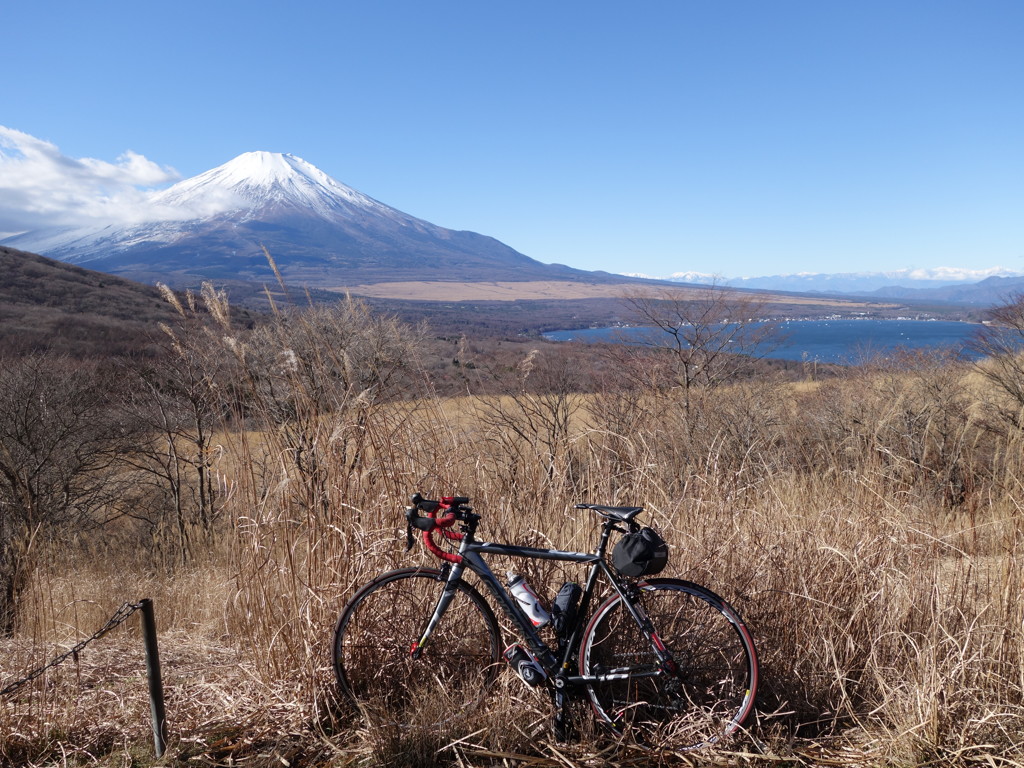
[230,299,426,510]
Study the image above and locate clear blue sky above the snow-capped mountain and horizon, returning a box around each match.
[0,0,1024,278]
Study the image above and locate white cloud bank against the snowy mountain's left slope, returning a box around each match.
[0,126,179,233]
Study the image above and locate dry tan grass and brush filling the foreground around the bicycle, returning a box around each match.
[0,292,1024,766]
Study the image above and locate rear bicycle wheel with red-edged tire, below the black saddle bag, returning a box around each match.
[580,579,758,750]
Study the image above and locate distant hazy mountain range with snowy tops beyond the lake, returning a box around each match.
[632,267,1024,305]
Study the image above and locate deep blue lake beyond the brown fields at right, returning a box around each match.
[544,318,979,365]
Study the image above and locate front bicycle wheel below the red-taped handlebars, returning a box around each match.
[333,568,501,727]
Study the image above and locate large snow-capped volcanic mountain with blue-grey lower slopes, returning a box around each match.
[0,152,598,288]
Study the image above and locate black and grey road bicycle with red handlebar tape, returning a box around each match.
[333,495,758,749]
